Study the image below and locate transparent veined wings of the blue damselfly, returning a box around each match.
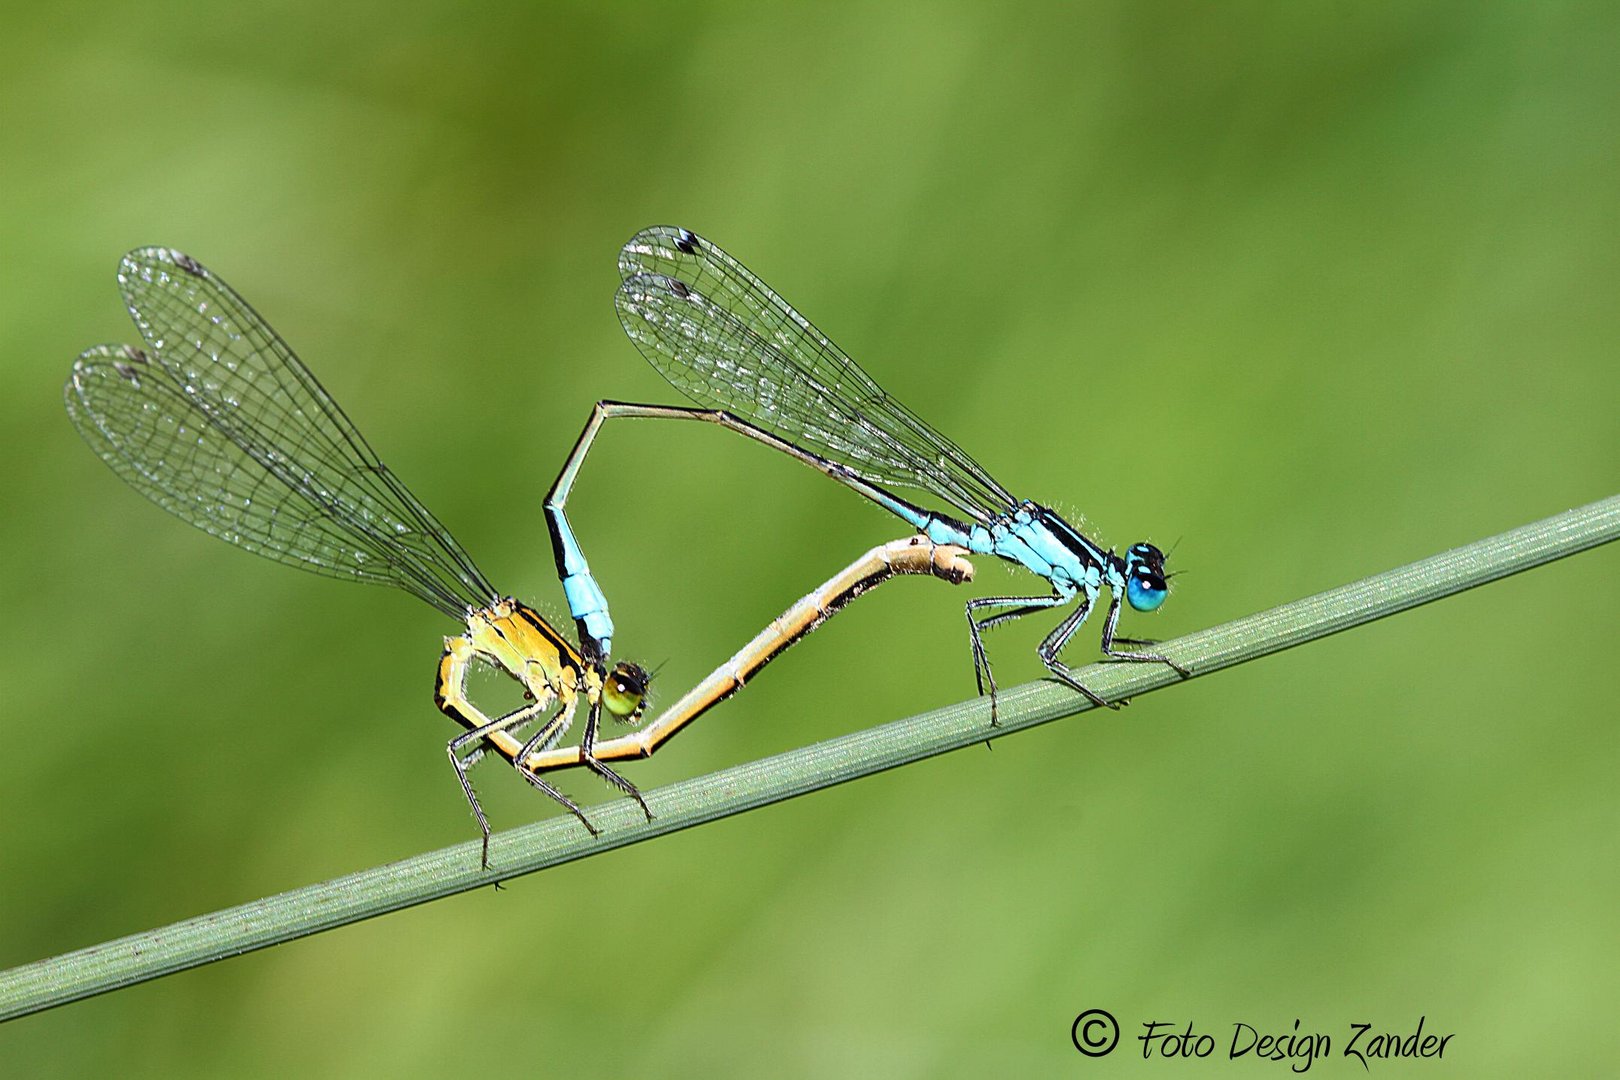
[616,225,1016,521]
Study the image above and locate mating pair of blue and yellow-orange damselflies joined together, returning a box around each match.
[66,228,1184,866]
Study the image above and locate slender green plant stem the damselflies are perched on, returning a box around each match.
[0,495,1620,1020]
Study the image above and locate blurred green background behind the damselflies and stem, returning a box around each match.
[0,3,1620,1077]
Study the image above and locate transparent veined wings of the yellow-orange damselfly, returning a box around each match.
[66,248,496,619]
